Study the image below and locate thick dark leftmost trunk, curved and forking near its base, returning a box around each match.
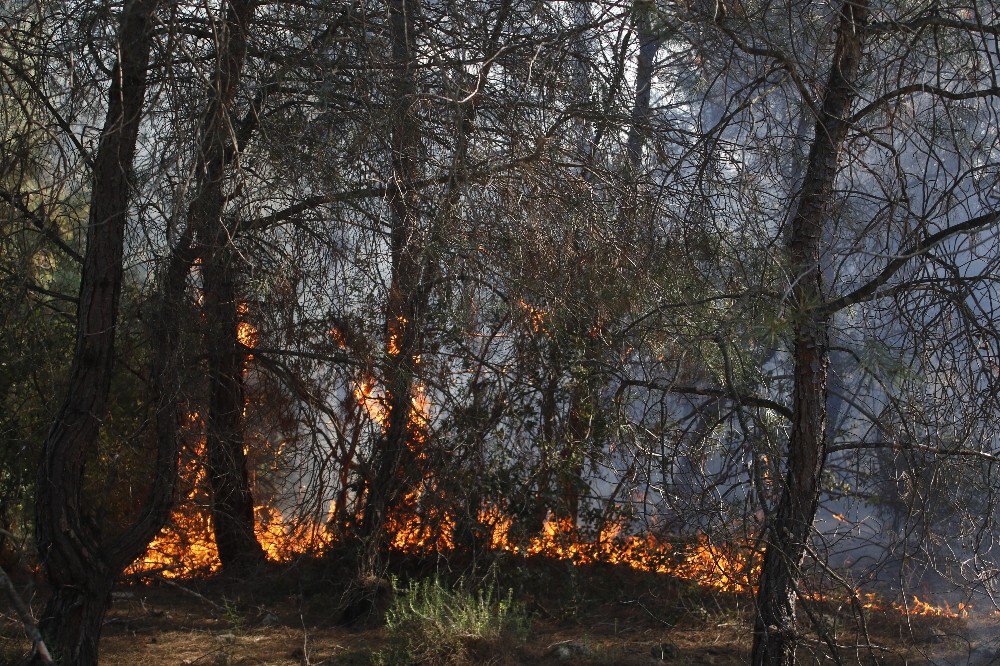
[35,0,163,666]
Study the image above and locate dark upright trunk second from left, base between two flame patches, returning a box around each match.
[189,0,264,572]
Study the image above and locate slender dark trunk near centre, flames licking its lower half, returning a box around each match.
[362,0,430,552]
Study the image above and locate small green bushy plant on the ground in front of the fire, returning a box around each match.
[375,577,529,665]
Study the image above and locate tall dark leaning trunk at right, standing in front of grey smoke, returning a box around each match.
[752,0,868,666]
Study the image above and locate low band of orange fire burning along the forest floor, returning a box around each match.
[128,447,972,619]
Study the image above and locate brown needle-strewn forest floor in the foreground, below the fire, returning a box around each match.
[0,562,1000,666]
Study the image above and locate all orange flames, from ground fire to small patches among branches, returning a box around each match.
[127,310,972,618]
